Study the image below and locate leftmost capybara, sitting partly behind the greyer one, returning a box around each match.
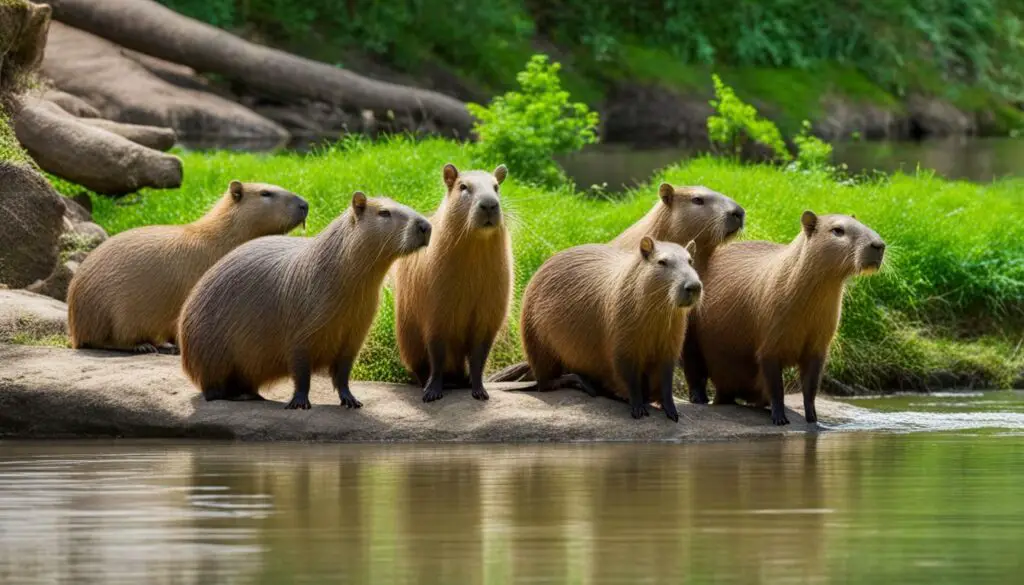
[68,180,309,353]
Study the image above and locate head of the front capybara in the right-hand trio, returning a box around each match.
[637,236,703,307]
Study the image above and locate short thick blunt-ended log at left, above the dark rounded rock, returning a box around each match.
[12,96,182,196]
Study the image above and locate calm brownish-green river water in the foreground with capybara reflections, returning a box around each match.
[0,392,1024,585]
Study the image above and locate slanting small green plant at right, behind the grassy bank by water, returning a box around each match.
[708,74,793,162]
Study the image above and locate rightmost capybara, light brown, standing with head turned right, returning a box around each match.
[683,211,886,424]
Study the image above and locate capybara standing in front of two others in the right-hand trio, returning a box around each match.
[520,238,701,422]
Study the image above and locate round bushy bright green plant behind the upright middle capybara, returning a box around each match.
[469,54,598,184]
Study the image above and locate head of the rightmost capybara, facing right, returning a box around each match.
[800,211,886,277]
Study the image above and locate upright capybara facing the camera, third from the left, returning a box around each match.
[394,164,513,402]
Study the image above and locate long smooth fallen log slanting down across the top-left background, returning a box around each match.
[39,0,472,136]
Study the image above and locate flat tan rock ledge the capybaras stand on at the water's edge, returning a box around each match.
[0,345,856,443]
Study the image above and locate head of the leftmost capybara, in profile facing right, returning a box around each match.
[225,180,309,238]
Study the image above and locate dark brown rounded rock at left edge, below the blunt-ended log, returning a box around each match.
[0,162,65,289]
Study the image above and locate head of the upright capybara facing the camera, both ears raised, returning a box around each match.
[442,163,508,232]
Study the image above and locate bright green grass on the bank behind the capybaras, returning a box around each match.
[94,139,1024,388]
